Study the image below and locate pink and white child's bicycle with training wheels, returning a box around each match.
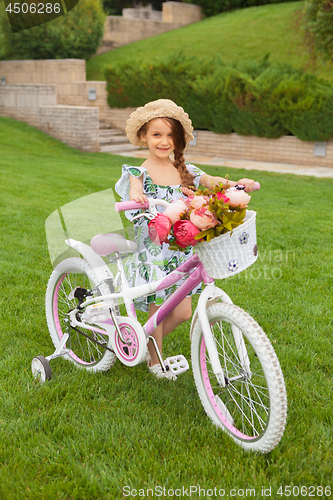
[32,190,287,453]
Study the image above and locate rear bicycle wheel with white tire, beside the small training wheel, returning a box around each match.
[45,257,117,372]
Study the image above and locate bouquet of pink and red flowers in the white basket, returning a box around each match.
[148,183,251,250]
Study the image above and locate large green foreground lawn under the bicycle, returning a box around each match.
[0,117,333,500]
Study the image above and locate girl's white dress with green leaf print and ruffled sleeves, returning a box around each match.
[115,163,205,311]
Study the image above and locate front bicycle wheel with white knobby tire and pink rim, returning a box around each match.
[192,302,287,453]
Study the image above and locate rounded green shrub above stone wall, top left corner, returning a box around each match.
[0,0,105,59]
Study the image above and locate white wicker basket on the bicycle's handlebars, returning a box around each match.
[193,210,258,279]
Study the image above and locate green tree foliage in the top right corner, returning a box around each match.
[303,0,333,60]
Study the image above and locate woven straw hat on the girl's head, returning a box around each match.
[126,99,194,146]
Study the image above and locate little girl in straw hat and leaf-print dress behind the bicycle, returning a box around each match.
[115,99,255,380]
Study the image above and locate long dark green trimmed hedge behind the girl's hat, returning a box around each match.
[105,53,333,141]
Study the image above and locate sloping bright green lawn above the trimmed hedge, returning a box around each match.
[87,2,333,80]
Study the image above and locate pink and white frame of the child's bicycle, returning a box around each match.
[66,200,250,387]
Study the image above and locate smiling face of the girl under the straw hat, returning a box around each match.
[141,118,175,159]
